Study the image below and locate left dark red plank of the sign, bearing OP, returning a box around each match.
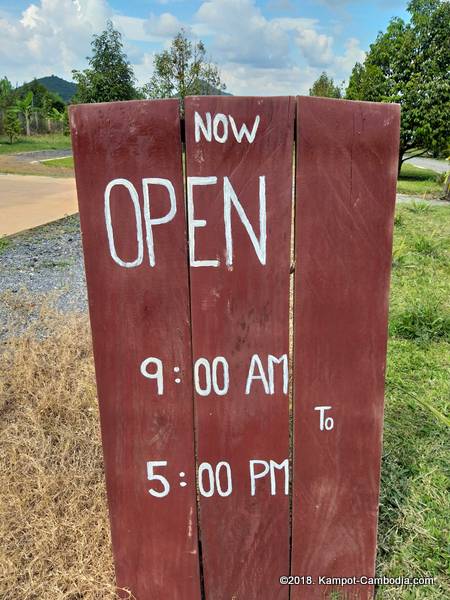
[70,100,200,600]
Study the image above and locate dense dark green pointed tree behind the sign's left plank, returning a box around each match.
[72,21,139,103]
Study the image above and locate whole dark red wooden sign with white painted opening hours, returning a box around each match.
[70,97,399,600]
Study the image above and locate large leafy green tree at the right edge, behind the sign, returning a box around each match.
[346,0,450,169]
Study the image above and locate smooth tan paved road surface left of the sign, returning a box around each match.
[0,175,78,236]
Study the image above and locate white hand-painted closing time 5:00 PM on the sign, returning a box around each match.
[147,458,289,498]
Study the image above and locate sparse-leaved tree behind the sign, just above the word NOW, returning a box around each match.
[144,29,225,101]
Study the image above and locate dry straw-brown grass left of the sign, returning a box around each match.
[0,303,126,600]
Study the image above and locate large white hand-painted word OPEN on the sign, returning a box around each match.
[104,175,267,268]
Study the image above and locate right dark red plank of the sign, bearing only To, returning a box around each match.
[291,98,399,600]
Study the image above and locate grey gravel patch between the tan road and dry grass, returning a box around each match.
[0,215,87,336]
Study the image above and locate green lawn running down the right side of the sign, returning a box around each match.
[377,203,450,600]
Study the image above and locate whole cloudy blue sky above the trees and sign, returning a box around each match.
[0,0,408,95]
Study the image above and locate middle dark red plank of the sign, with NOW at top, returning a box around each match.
[186,97,294,600]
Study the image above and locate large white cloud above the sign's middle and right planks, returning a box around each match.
[192,0,363,94]
